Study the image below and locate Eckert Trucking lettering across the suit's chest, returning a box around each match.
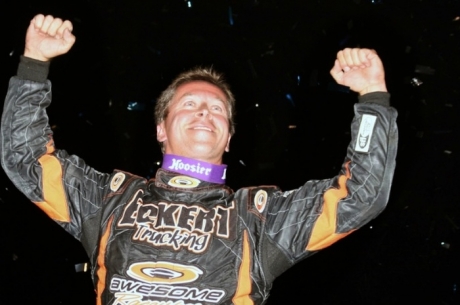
[117,190,236,254]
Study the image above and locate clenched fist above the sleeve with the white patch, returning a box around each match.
[331,48,387,95]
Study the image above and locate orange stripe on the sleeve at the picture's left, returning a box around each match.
[34,151,70,222]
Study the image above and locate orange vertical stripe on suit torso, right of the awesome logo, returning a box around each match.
[232,230,254,305]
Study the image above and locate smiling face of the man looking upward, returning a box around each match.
[157,81,231,164]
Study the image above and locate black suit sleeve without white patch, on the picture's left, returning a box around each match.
[1,57,109,243]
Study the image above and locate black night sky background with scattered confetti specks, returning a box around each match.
[0,0,460,304]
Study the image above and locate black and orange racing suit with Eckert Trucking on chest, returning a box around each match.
[1,58,397,305]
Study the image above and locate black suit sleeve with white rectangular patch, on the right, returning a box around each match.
[265,92,398,266]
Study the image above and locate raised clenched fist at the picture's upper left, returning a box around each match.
[24,15,75,61]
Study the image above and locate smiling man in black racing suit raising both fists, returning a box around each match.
[2,15,397,304]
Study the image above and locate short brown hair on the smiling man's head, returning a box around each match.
[155,67,235,135]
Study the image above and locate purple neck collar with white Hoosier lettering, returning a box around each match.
[161,154,227,184]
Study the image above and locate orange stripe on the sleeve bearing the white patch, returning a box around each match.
[306,163,353,251]
